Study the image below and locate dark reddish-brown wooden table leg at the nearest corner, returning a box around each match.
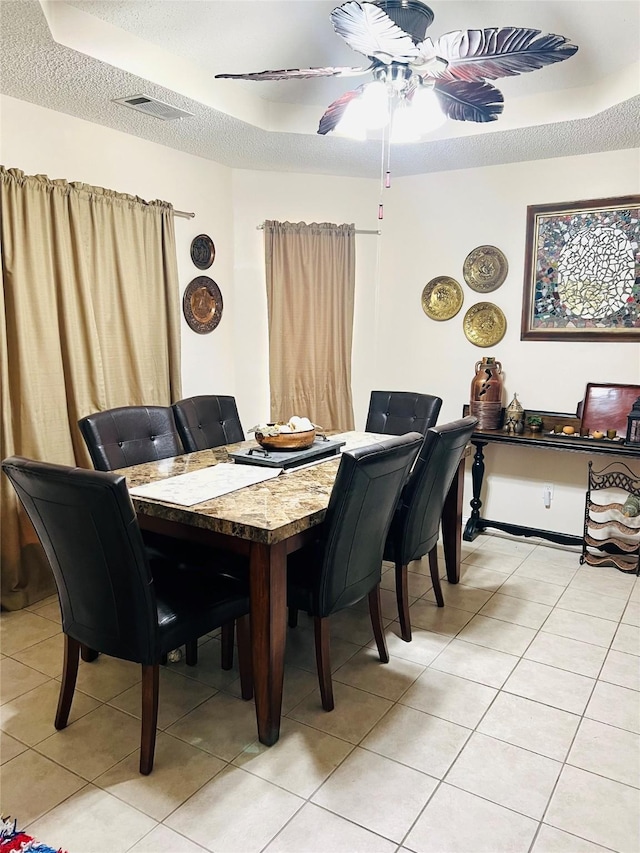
[250,542,287,746]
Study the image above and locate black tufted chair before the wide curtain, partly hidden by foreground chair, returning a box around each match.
[78,406,234,669]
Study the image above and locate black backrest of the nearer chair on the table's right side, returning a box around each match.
[315,432,424,616]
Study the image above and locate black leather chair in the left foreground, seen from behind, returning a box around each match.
[2,456,253,775]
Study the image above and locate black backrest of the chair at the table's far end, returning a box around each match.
[365,391,442,435]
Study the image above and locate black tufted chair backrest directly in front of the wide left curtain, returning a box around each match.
[78,406,184,471]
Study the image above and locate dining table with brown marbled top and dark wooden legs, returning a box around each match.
[118,431,464,746]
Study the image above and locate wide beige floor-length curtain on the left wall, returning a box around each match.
[0,166,181,610]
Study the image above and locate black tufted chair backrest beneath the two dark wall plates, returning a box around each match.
[173,394,244,453]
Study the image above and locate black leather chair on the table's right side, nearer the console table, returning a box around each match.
[384,417,478,642]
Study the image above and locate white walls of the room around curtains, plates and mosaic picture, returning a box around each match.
[0,96,640,534]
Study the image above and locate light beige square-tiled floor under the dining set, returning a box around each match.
[0,534,640,853]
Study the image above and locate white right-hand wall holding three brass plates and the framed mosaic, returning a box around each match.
[376,150,640,535]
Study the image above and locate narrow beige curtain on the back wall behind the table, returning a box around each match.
[264,221,355,430]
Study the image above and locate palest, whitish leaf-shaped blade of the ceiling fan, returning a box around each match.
[329,0,418,65]
